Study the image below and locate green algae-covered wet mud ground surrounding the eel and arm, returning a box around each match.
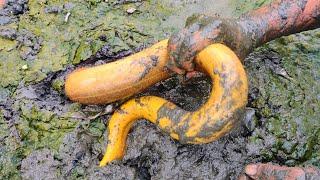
[0,0,320,179]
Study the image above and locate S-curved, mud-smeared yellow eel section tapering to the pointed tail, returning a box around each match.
[100,42,248,166]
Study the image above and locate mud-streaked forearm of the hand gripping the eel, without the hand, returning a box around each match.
[238,0,320,47]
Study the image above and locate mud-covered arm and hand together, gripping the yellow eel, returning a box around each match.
[168,0,320,74]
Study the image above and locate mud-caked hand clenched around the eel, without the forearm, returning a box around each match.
[167,14,246,75]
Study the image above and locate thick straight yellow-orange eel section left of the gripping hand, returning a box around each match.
[65,40,170,104]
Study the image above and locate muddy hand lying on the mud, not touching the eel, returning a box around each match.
[239,163,320,180]
